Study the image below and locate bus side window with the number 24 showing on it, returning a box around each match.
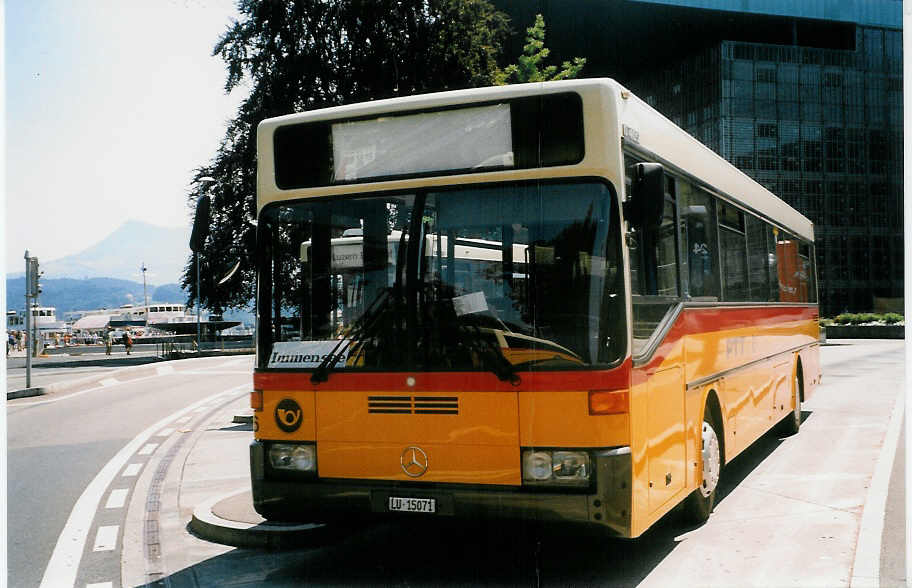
[678,182,719,300]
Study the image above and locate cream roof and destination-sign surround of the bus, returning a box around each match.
[257,78,814,241]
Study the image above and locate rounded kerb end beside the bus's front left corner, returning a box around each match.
[187,488,328,549]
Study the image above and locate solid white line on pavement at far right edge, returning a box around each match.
[850,388,906,588]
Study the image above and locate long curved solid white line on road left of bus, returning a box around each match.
[41,384,250,588]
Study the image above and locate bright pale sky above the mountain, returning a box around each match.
[4,0,245,273]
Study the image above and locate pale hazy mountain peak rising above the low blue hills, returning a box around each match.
[14,220,190,284]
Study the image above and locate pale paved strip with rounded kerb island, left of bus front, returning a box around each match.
[122,394,330,586]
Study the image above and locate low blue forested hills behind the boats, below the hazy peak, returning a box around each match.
[6,278,187,319]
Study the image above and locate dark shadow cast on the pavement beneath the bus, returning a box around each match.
[155,411,811,587]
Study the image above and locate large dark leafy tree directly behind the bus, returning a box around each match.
[182,0,508,311]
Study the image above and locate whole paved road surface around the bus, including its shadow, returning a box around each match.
[8,341,904,587]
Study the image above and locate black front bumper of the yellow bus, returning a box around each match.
[250,441,631,537]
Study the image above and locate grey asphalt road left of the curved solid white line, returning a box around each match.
[7,357,251,586]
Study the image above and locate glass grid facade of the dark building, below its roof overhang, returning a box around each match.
[629,27,903,315]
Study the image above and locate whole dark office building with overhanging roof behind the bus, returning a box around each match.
[500,0,903,315]
